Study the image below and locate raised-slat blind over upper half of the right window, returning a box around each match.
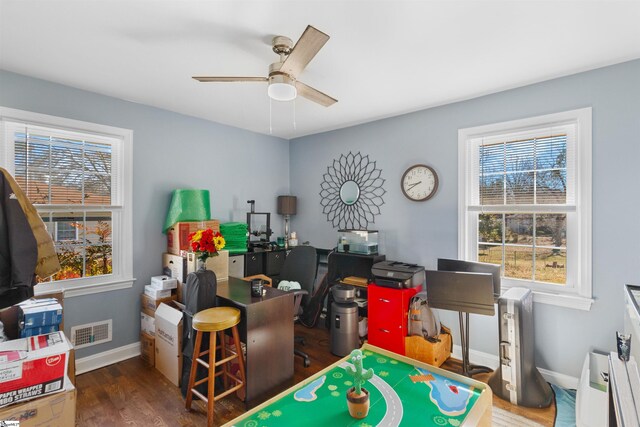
[468,125,576,212]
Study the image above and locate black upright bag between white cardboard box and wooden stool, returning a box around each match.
[181,270,218,398]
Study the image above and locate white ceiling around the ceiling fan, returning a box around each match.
[0,0,640,138]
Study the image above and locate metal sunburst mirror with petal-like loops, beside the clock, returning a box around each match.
[320,152,387,229]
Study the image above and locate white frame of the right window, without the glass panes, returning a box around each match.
[458,108,593,310]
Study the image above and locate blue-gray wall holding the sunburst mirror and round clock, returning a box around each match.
[290,60,640,377]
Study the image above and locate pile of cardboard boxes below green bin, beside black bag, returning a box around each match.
[140,220,229,386]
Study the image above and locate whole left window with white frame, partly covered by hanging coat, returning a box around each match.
[0,107,133,296]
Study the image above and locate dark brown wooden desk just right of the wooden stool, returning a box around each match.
[217,277,293,407]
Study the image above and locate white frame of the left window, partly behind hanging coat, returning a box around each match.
[0,106,135,298]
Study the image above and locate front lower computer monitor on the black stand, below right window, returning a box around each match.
[425,270,495,316]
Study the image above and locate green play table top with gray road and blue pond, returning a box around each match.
[226,344,491,427]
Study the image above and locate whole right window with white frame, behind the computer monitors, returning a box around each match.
[459,108,592,309]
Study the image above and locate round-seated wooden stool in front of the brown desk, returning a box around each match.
[185,307,246,427]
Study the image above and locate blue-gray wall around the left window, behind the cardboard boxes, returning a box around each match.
[0,70,289,358]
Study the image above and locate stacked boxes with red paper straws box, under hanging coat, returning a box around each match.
[0,298,76,426]
